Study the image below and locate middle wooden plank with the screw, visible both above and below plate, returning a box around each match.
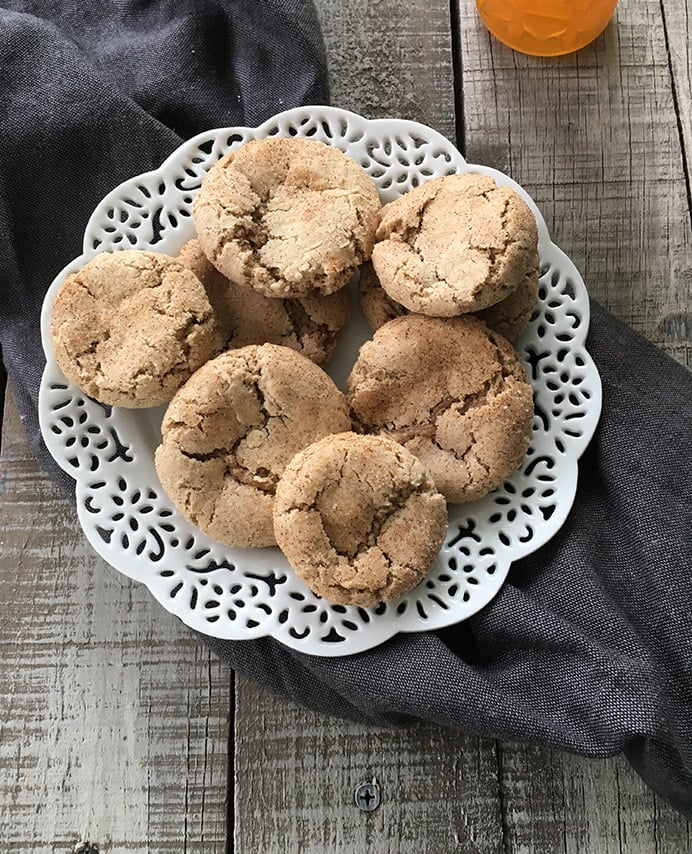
[235,0,503,854]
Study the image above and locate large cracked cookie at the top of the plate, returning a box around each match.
[193,138,380,297]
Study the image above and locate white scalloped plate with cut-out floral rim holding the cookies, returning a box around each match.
[39,107,601,656]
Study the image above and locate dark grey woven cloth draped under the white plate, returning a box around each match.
[0,0,692,814]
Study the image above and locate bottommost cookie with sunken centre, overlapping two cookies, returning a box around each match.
[274,433,447,606]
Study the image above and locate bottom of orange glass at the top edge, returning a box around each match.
[476,0,617,56]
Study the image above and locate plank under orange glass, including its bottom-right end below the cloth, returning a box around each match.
[458,2,692,854]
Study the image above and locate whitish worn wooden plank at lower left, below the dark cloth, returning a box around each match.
[0,398,231,854]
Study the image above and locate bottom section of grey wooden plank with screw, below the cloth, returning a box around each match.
[235,679,504,854]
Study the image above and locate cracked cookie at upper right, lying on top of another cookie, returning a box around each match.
[372,174,538,317]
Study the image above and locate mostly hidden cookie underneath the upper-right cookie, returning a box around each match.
[358,254,538,341]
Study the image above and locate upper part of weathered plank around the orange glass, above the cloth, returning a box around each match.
[459,0,692,365]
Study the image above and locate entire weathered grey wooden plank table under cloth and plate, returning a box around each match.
[0,0,692,854]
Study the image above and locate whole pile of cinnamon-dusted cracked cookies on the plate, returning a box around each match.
[51,138,538,606]
